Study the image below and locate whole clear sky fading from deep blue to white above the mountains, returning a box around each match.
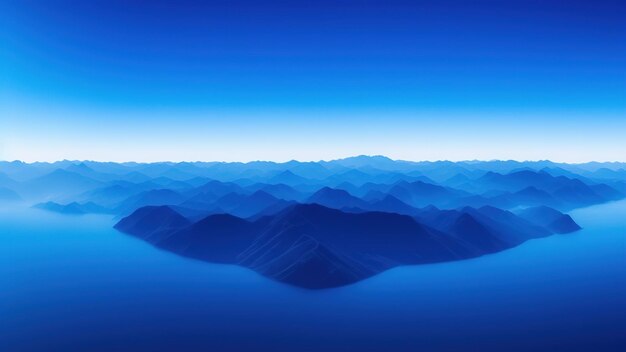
[0,0,626,162]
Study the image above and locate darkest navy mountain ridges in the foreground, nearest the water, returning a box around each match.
[116,204,576,288]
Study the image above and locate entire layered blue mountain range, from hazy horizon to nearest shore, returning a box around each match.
[0,156,626,288]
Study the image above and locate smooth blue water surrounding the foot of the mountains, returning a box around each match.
[0,201,626,351]
